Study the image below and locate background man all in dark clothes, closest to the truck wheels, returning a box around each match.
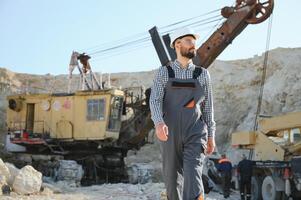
[237,154,254,200]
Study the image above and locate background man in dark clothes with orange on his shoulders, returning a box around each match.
[217,154,232,198]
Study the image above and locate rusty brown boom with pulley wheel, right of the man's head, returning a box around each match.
[193,0,274,68]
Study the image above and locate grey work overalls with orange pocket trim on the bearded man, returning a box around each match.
[161,66,207,200]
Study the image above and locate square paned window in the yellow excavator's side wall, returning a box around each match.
[87,99,105,121]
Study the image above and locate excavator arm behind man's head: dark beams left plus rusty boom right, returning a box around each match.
[149,0,274,68]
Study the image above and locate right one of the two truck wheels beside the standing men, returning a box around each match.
[261,176,281,200]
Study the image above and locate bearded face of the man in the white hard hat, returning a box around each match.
[179,36,196,59]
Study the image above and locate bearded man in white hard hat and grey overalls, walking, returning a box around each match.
[150,28,215,200]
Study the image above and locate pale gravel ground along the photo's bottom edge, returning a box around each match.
[0,183,239,200]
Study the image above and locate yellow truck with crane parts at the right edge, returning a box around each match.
[232,112,301,200]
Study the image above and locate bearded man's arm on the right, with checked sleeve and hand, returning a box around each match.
[201,70,215,154]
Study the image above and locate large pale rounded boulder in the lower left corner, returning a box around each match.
[13,165,42,195]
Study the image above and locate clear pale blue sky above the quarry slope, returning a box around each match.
[0,0,301,75]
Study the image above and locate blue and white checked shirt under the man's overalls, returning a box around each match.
[150,60,215,137]
